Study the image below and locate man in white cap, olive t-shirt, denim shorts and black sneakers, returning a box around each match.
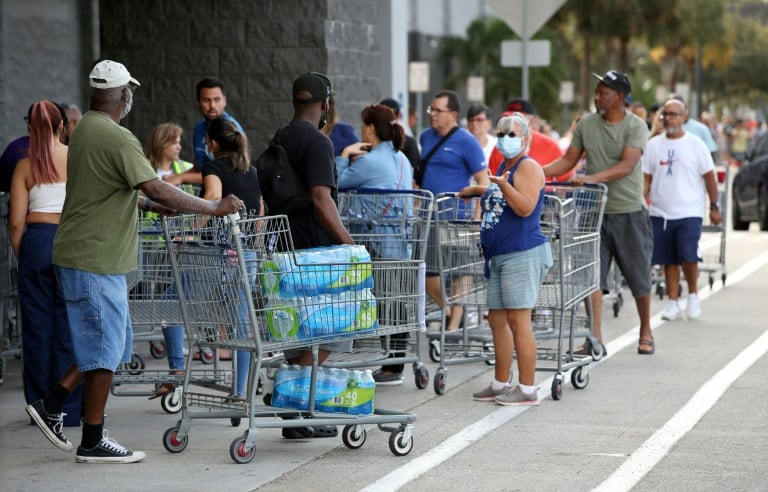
[26,60,242,463]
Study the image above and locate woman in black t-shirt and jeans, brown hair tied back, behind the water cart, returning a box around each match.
[203,118,264,399]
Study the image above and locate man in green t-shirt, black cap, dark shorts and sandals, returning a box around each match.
[544,70,655,355]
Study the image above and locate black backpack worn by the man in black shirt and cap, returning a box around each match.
[256,131,310,215]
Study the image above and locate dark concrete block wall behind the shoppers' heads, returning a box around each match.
[99,0,381,160]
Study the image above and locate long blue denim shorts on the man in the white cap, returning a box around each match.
[56,266,133,372]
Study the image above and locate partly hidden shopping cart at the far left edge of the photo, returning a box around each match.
[0,191,21,384]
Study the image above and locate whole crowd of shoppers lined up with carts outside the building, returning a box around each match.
[4,60,728,463]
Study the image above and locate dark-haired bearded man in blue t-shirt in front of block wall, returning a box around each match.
[163,78,245,186]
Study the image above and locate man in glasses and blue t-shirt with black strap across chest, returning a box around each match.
[420,90,489,330]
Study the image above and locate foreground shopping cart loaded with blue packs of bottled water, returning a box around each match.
[163,215,424,463]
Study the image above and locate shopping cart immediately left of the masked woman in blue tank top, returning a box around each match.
[427,193,495,395]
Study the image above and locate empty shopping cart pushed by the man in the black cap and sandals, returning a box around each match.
[534,185,607,400]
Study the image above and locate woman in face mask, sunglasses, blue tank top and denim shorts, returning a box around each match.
[459,113,553,405]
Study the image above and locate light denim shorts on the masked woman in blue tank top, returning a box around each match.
[488,242,553,309]
